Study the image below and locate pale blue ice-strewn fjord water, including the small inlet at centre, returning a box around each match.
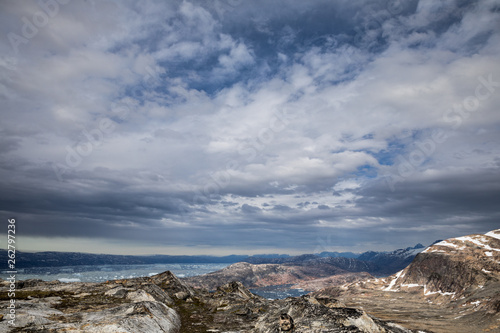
[0,263,307,299]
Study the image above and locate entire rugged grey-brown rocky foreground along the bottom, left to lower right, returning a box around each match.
[0,272,430,333]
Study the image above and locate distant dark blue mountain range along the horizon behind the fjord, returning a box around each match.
[0,244,424,276]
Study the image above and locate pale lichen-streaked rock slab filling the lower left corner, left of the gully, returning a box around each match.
[0,279,184,333]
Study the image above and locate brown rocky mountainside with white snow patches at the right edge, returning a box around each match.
[322,229,500,333]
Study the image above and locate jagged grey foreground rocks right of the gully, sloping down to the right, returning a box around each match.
[187,282,418,333]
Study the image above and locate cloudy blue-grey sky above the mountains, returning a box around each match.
[0,0,500,255]
